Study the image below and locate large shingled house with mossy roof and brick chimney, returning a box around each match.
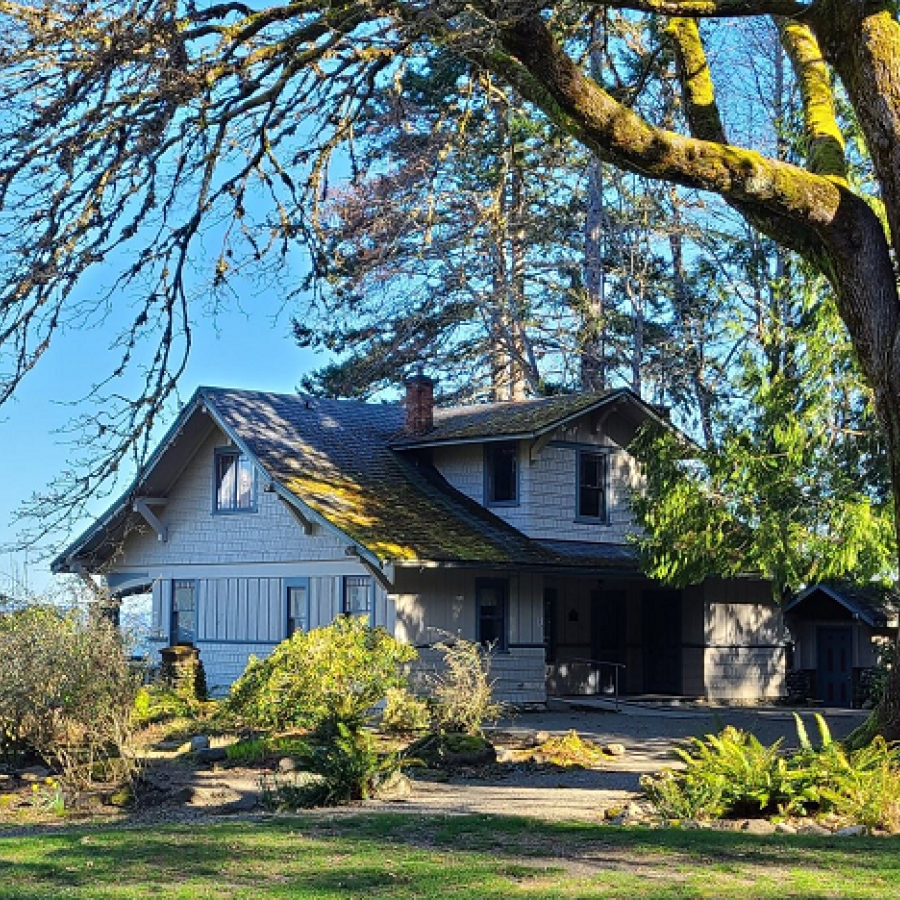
[54,375,785,704]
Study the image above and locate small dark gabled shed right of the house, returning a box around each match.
[784,582,900,707]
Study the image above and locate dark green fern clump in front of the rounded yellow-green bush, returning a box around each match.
[263,722,402,808]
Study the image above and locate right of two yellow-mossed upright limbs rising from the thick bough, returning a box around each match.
[778,19,847,185]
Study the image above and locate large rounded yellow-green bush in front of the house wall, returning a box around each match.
[227,616,416,732]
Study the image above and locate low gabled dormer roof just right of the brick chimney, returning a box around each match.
[392,388,671,448]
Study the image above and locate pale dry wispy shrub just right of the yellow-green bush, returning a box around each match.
[428,637,502,734]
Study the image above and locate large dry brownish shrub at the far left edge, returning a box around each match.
[0,606,138,788]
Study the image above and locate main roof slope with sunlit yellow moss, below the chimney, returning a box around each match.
[202,388,631,568]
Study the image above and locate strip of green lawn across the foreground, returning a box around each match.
[0,814,900,900]
